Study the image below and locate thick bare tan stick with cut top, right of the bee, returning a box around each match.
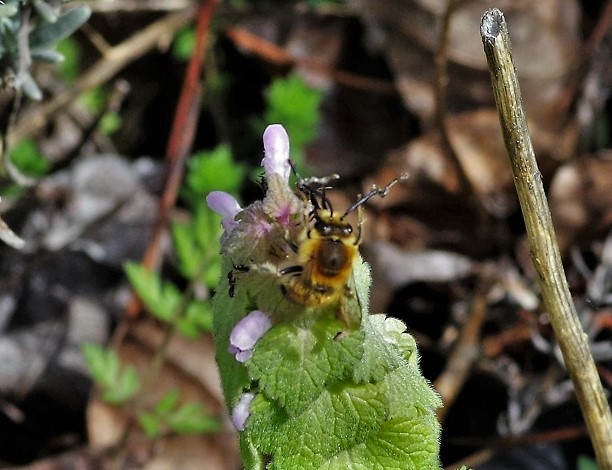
[480,8,612,470]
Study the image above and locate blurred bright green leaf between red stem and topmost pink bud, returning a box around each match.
[183,145,246,207]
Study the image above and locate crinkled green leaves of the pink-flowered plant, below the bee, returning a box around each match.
[213,262,440,470]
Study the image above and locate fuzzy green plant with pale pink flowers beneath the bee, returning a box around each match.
[207,125,441,470]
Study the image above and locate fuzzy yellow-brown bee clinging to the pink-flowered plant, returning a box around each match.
[279,174,408,327]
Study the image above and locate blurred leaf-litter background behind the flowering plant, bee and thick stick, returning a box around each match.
[0,0,612,470]
